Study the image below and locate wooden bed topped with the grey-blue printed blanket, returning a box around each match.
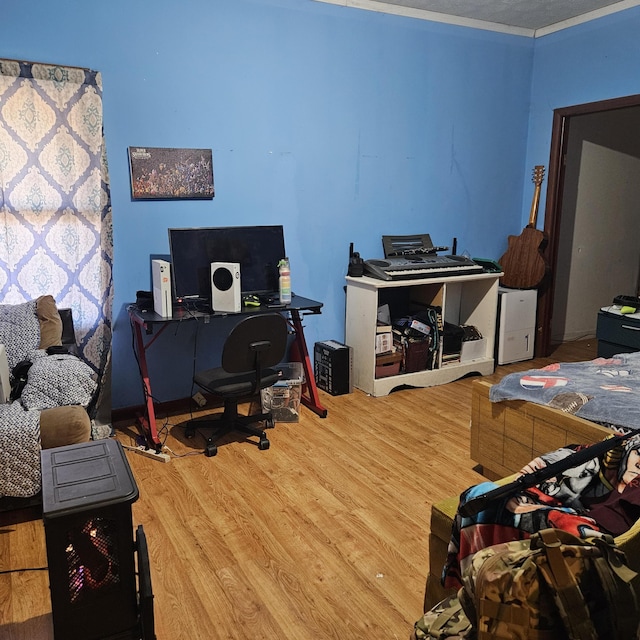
[464,352,640,479]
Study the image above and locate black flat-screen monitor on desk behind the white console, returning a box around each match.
[169,225,286,301]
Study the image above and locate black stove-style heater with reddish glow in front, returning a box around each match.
[41,439,155,640]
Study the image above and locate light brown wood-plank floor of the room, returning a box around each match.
[0,340,596,640]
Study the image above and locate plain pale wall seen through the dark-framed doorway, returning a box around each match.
[551,107,640,342]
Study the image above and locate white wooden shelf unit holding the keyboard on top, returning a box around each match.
[345,273,502,397]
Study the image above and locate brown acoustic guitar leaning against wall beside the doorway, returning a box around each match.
[499,165,547,289]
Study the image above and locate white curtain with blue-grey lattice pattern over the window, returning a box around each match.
[0,59,113,430]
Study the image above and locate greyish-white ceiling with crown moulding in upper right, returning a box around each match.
[317,0,640,37]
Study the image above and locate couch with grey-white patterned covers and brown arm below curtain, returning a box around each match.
[0,295,97,510]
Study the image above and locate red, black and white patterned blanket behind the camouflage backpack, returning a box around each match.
[442,435,640,588]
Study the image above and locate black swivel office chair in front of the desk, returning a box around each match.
[185,313,288,457]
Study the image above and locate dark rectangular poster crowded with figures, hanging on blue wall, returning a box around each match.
[129,147,215,200]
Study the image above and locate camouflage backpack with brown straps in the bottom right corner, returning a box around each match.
[458,529,638,640]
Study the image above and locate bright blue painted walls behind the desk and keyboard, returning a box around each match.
[5,0,640,408]
